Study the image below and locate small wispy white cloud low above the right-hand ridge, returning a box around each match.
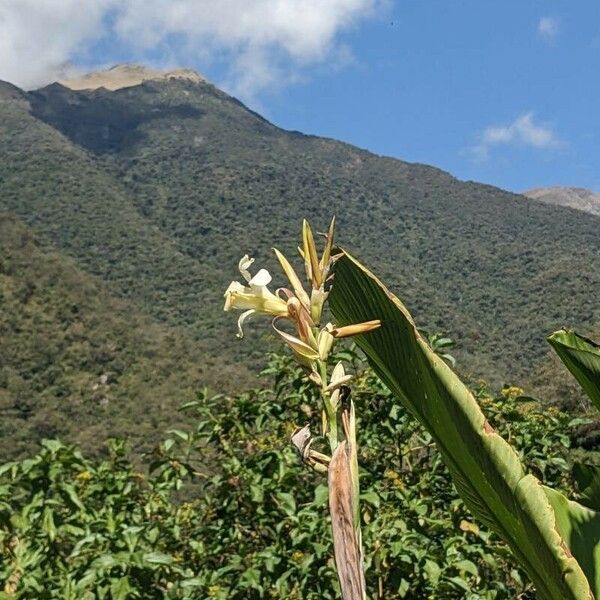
[471,112,561,160]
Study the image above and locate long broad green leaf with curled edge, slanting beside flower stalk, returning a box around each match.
[330,253,597,600]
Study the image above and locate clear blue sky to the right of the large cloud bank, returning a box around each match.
[262,0,600,191]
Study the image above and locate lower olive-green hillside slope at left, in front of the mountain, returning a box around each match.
[0,215,251,457]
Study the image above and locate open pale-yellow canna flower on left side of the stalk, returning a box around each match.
[223,254,288,338]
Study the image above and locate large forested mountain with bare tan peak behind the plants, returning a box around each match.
[0,67,600,452]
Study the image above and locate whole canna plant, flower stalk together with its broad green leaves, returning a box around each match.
[225,222,600,600]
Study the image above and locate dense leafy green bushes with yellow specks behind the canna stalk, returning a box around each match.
[0,351,592,600]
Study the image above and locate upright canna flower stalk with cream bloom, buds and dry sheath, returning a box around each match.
[224,218,380,600]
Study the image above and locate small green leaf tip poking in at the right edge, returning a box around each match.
[547,329,600,410]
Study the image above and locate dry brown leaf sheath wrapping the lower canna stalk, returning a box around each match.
[329,440,366,600]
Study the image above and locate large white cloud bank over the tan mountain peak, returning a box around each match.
[0,0,389,97]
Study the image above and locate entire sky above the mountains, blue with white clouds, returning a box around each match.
[0,0,600,191]
